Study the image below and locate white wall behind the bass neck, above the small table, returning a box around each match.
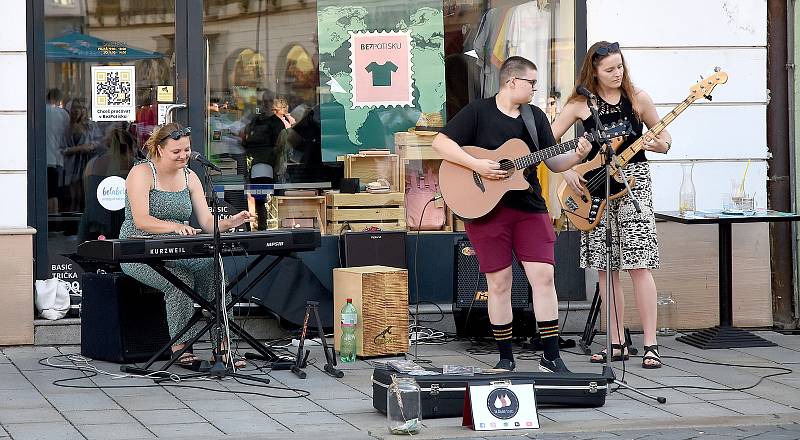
[587,0,768,210]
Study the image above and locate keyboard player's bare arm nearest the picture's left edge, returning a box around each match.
[125,164,187,234]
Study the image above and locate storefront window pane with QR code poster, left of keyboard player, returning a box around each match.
[42,0,175,260]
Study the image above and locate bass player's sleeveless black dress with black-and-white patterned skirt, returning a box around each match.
[580,96,659,271]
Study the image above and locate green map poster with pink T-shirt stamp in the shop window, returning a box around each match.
[317,0,445,161]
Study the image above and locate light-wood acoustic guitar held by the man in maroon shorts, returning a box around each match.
[439,122,631,219]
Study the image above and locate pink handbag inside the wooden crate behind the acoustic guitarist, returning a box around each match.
[406,169,445,231]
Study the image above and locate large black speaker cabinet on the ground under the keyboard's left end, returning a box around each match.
[81,273,170,363]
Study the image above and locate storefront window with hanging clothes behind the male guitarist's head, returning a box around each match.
[444,0,575,121]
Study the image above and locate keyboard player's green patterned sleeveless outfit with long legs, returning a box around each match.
[119,161,231,344]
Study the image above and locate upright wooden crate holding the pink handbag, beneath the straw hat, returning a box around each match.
[394,132,453,233]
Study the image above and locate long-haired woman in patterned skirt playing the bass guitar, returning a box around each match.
[553,41,672,369]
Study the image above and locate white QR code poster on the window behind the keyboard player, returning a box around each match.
[92,66,136,121]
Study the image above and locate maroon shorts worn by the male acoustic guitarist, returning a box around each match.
[466,206,556,273]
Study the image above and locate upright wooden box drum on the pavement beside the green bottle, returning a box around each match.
[333,266,408,357]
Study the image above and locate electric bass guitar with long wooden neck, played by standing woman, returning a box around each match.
[558,67,728,231]
